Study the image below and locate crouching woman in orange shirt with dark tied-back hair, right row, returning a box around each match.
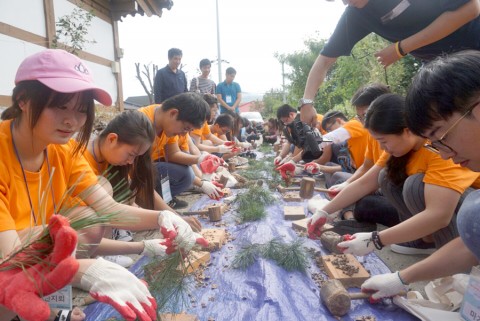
[308,94,479,255]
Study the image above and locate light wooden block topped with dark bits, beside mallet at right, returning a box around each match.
[322,254,370,289]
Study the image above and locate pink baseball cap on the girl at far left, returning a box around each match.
[15,49,112,106]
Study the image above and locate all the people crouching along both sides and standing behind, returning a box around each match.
[0,0,480,321]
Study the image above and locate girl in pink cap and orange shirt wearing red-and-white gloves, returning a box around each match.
[0,49,208,321]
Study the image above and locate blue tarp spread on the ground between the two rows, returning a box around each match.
[85,165,418,321]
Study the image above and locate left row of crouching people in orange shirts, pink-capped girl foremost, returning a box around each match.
[0,49,258,321]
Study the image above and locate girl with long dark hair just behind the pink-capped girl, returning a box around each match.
[83,111,202,232]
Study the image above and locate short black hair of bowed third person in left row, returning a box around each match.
[162,92,210,128]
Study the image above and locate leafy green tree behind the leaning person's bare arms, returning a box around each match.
[282,34,420,114]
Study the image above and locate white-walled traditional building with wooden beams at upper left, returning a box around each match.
[0,0,173,110]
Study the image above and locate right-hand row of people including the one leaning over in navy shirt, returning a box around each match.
[274,0,480,308]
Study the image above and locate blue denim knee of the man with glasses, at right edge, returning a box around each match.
[457,190,480,259]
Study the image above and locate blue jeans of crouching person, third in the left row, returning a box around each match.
[153,162,195,197]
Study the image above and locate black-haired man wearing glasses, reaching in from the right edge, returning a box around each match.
[354,51,480,299]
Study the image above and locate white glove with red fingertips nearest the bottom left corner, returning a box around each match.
[80,258,157,321]
